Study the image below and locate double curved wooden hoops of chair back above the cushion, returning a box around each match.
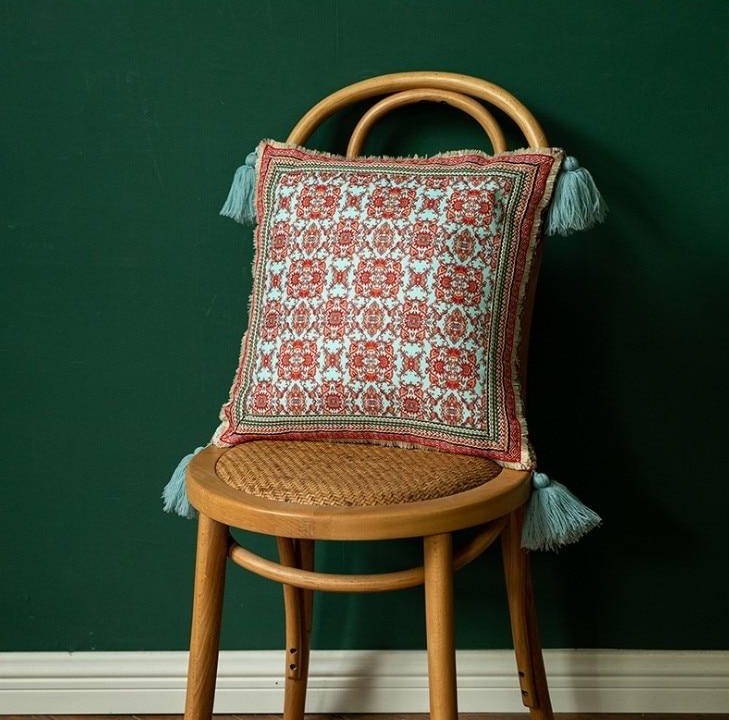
[288,71,548,150]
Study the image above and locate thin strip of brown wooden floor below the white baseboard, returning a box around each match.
[0,713,729,720]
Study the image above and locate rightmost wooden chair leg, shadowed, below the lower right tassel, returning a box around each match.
[501,510,554,720]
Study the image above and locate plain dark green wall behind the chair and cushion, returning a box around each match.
[0,0,729,651]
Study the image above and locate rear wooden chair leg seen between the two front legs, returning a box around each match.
[277,538,314,720]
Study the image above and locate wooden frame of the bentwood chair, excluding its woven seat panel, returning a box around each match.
[185,72,552,720]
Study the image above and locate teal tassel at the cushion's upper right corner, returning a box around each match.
[546,157,607,235]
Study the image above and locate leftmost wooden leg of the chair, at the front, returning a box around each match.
[185,513,228,720]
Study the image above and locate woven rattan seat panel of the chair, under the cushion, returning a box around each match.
[216,441,501,507]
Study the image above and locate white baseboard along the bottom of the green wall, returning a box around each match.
[0,650,729,715]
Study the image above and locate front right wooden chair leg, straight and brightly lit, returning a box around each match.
[423,534,458,720]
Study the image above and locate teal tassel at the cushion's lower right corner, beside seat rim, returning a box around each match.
[521,472,602,550]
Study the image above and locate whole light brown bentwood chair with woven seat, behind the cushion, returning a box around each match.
[185,72,552,720]
